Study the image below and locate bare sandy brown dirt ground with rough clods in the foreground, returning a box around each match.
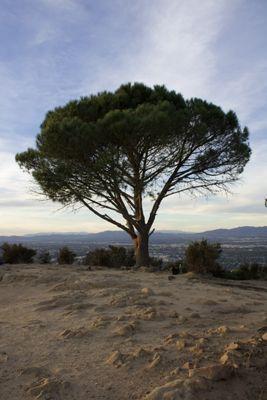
[0,265,267,400]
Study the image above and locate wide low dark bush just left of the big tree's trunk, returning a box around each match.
[84,246,135,268]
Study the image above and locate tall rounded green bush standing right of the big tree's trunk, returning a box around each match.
[185,240,222,275]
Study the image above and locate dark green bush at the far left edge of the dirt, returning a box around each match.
[1,243,36,264]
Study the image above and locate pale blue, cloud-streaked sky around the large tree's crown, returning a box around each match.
[0,0,267,235]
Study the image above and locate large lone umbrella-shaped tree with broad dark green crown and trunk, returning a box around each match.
[16,83,250,266]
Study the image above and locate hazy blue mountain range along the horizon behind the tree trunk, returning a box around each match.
[0,226,267,244]
